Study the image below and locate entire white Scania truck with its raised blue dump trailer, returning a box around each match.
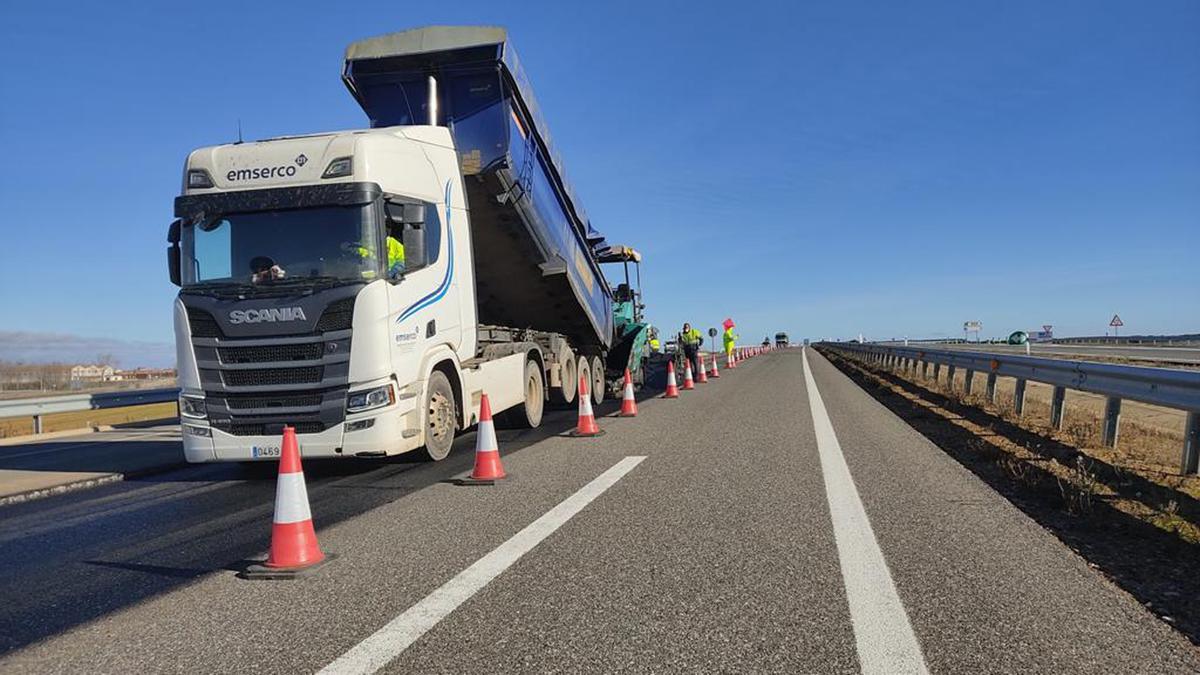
[168,26,648,462]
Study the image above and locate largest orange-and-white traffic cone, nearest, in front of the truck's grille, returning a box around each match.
[241,426,326,579]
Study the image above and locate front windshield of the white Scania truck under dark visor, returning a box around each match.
[181,205,383,287]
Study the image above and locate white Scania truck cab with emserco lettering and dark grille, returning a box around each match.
[170,127,499,461]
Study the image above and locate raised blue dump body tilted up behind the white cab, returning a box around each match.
[342,26,613,352]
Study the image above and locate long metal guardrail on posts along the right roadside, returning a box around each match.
[818,342,1200,474]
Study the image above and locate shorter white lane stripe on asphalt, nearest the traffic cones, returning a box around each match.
[320,456,646,674]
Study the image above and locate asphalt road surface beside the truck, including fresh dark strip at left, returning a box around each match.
[0,350,1200,674]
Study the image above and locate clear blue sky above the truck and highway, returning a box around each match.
[0,0,1200,365]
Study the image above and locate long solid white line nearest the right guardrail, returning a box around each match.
[800,350,929,675]
